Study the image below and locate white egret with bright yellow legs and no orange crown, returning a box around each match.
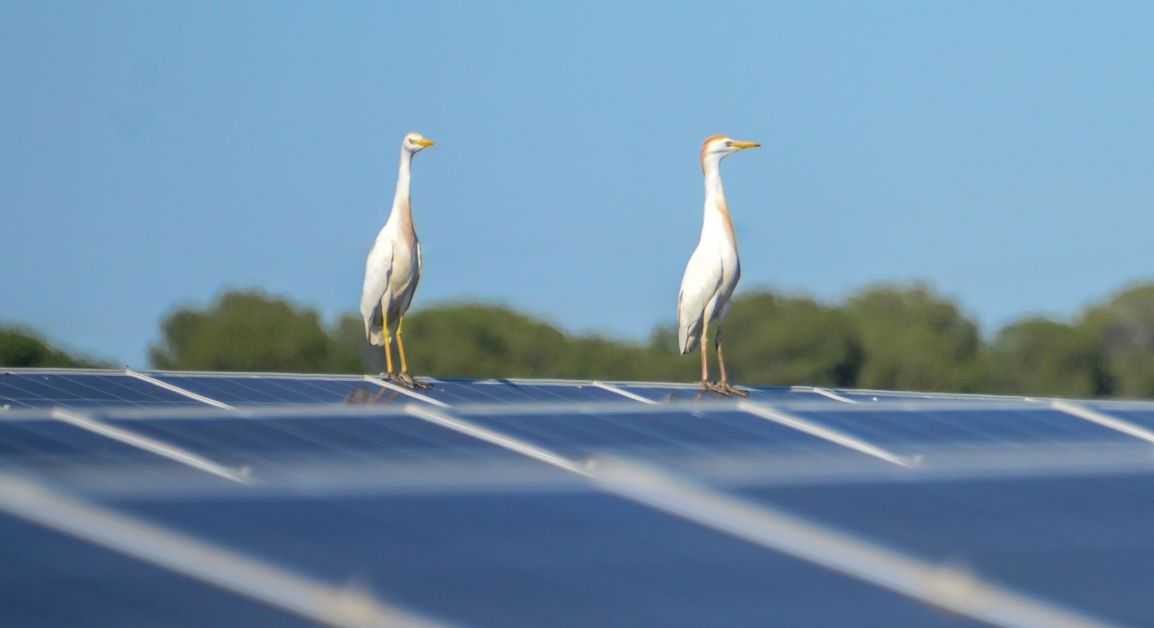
[361,133,433,388]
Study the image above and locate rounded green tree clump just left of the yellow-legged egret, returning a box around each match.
[149,290,362,373]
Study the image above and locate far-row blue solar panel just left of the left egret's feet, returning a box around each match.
[152,373,394,405]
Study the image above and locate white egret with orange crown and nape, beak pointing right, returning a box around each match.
[677,135,760,396]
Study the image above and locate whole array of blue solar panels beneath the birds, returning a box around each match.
[0,369,1154,626]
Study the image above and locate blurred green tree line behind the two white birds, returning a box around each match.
[0,284,1154,397]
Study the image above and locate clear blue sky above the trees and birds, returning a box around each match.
[0,0,1154,366]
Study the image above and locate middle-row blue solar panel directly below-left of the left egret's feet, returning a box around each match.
[106,414,524,469]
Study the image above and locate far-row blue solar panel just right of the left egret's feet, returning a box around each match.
[419,380,629,405]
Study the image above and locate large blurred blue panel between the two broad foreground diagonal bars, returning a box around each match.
[112,493,961,627]
